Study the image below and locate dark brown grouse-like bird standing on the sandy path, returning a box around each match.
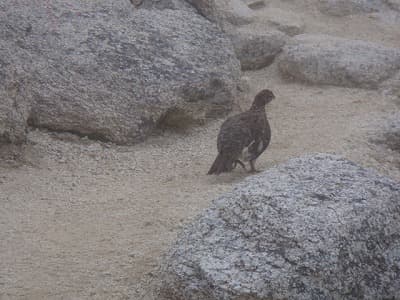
[207,89,275,175]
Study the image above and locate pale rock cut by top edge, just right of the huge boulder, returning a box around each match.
[187,0,255,28]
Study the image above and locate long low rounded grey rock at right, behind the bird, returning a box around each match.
[279,34,400,89]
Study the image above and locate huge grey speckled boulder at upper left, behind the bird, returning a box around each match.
[0,0,240,144]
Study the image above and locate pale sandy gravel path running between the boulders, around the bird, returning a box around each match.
[0,1,400,300]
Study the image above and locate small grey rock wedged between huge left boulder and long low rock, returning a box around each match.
[229,27,287,70]
